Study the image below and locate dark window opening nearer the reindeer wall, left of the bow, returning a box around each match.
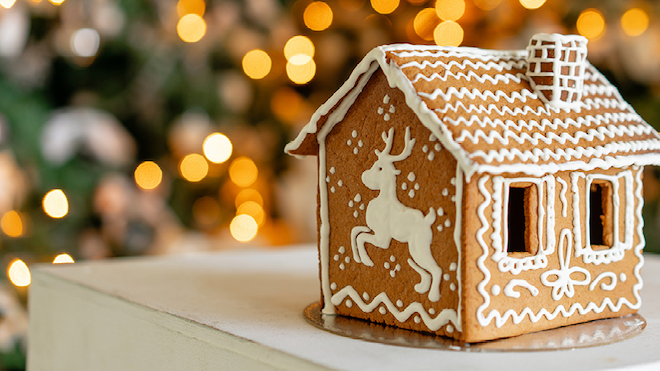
[506,183,539,256]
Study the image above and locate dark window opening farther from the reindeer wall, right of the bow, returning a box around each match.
[589,179,614,250]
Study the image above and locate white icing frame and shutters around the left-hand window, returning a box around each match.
[491,175,556,275]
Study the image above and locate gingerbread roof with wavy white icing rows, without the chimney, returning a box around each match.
[285,44,660,178]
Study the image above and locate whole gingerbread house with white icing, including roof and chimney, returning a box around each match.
[286,34,660,342]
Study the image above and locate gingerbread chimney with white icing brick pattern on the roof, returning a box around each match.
[527,33,587,109]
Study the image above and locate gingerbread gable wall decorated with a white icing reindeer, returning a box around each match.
[319,70,462,337]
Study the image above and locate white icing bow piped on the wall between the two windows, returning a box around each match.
[541,229,591,300]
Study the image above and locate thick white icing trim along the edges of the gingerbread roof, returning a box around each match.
[285,44,660,179]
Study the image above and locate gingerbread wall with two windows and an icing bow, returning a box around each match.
[463,168,644,341]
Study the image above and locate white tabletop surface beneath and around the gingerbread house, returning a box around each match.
[28,246,660,371]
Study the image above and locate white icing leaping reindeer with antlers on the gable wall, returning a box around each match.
[351,127,442,302]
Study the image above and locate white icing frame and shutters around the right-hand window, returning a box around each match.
[571,170,635,265]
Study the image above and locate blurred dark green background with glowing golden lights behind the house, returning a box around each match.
[0,0,660,370]
